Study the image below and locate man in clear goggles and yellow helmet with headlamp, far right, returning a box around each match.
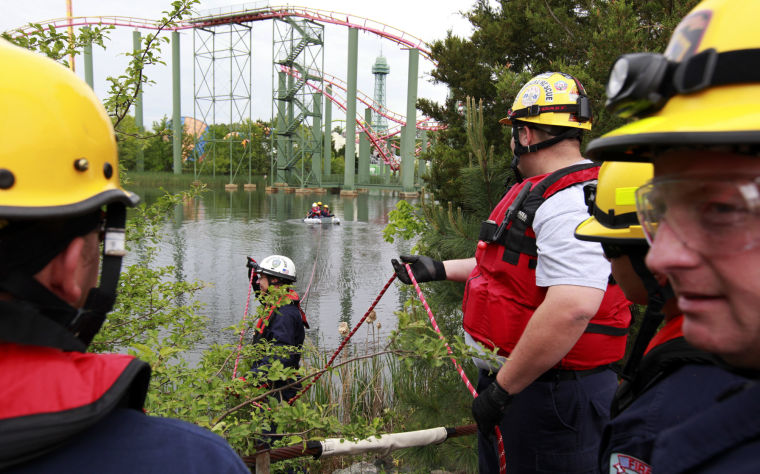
[588,0,760,473]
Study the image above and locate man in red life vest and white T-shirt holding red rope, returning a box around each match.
[392,72,630,472]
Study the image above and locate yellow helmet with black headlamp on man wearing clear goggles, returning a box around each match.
[587,0,760,161]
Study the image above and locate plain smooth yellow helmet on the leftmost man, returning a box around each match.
[0,40,139,219]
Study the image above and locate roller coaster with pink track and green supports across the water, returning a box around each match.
[8,4,445,194]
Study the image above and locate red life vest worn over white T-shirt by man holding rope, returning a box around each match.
[462,163,631,370]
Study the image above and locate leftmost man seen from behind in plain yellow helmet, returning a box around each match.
[0,40,247,473]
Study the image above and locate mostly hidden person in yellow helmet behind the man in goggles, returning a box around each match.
[575,161,746,474]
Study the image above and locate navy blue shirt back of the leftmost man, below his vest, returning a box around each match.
[6,408,250,474]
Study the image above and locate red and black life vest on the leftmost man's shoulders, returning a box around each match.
[0,343,150,468]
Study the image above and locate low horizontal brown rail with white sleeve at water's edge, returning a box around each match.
[243,425,478,465]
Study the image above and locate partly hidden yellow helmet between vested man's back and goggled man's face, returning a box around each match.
[575,161,654,244]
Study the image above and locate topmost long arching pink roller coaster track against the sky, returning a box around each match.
[11,4,434,62]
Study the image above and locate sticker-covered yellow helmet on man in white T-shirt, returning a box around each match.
[499,72,591,130]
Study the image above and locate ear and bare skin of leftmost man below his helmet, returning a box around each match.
[35,237,85,306]
